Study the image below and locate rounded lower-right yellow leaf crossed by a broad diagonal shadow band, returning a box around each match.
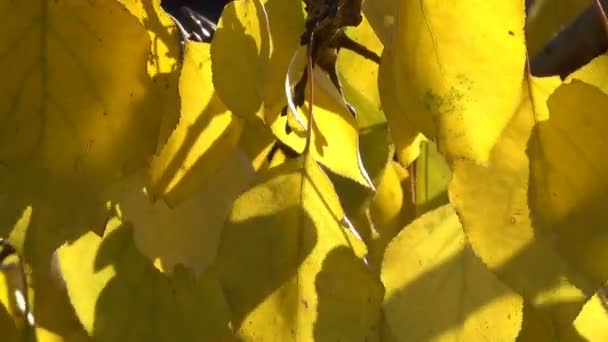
[382,206,523,341]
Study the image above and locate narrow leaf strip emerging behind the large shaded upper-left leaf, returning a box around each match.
[118,0,183,149]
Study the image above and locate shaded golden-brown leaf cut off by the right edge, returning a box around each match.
[528,80,608,291]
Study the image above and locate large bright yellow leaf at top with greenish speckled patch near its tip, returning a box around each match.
[392,0,526,163]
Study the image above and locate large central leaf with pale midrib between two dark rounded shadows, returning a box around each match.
[216,158,382,341]
